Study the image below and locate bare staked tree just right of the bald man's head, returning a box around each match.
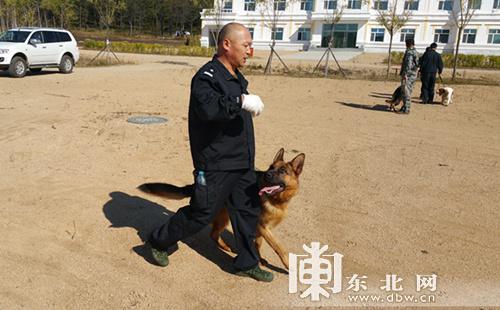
[256,0,296,74]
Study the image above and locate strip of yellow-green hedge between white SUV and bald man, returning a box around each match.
[83,40,215,57]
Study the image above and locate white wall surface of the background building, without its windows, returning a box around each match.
[201,0,500,55]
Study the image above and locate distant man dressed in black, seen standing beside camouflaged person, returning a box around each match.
[420,43,443,103]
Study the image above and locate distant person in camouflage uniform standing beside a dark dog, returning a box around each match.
[400,39,418,114]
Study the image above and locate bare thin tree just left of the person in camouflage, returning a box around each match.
[374,0,411,77]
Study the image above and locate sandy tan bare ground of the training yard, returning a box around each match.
[0,52,500,309]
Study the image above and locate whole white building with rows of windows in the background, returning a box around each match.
[201,0,500,55]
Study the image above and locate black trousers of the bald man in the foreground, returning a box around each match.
[149,169,261,270]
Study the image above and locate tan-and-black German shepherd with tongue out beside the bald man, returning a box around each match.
[139,148,305,270]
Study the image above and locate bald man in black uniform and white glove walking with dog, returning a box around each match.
[148,23,273,282]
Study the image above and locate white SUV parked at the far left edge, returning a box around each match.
[0,28,80,77]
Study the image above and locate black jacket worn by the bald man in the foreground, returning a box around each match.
[189,57,255,171]
